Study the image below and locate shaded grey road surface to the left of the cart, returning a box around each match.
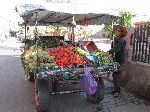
[0,55,34,112]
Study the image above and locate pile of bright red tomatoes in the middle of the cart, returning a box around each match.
[46,45,86,66]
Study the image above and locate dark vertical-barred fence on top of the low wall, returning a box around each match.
[131,22,150,64]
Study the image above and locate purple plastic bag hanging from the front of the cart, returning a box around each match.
[80,65,97,95]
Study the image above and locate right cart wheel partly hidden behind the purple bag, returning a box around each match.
[87,78,104,103]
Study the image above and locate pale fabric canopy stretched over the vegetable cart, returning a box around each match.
[16,3,122,26]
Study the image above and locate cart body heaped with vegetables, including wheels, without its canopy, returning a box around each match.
[21,36,118,112]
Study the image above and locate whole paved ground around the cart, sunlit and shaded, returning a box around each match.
[0,37,150,112]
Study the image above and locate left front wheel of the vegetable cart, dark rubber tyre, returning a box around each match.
[35,80,49,112]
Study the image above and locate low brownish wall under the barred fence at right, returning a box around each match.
[121,49,150,99]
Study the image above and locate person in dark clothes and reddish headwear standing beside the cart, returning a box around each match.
[108,26,126,97]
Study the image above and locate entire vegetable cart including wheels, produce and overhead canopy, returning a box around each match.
[17,3,120,112]
